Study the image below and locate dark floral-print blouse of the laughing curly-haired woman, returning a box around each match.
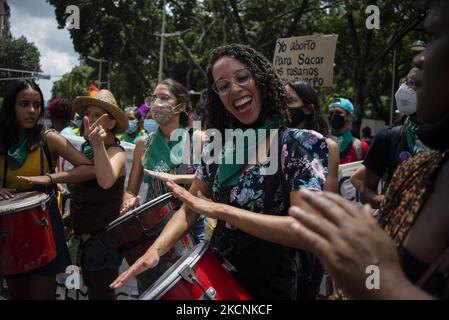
[195,128,328,214]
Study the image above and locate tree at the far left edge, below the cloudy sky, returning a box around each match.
[0,36,41,95]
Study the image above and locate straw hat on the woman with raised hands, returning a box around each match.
[72,89,128,133]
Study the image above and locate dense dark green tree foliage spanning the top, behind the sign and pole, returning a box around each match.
[47,0,426,125]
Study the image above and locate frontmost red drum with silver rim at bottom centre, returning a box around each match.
[139,243,252,300]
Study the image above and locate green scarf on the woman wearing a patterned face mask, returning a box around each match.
[144,125,187,183]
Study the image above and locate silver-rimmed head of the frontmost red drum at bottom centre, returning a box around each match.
[139,242,208,300]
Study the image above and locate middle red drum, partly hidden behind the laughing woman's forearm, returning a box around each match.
[106,193,196,291]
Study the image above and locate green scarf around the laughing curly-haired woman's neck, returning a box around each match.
[218,118,281,186]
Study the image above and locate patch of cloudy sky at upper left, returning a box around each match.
[8,0,79,101]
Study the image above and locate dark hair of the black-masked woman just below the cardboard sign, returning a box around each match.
[288,80,329,137]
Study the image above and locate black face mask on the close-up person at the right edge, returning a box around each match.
[418,114,449,150]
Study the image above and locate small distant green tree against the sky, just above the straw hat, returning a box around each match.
[51,65,96,100]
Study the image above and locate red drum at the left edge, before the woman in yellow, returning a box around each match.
[0,192,57,276]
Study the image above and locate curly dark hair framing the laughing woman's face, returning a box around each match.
[205,44,290,134]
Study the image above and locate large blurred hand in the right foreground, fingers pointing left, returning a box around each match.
[289,190,405,299]
